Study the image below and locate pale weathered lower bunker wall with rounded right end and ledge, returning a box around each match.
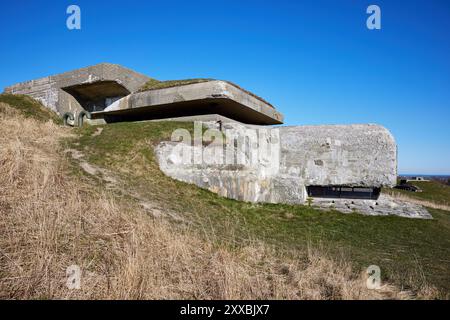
[156,122,429,218]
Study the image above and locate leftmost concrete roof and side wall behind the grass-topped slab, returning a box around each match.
[5,63,150,115]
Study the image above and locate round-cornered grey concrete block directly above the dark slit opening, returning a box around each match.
[280,124,397,187]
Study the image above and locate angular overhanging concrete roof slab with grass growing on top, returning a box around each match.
[92,80,283,125]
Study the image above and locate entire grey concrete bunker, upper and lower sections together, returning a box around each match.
[1,63,430,218]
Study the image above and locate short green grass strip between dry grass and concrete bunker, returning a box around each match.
[70,122,450,295]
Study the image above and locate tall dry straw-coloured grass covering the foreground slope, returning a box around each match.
[0,105,412,299]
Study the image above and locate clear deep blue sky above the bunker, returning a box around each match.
[0,0,450,174]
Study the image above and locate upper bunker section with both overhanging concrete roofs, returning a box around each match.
[5,63,283,125]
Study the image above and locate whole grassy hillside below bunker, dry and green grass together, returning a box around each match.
[0,95,450,299]
